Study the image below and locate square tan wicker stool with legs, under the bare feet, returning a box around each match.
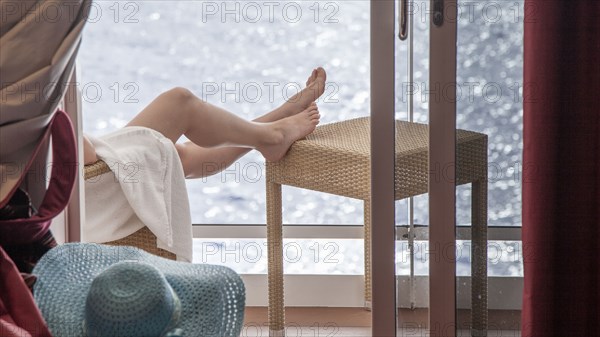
[266,118,487,335]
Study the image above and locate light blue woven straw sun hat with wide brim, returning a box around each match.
[33,243,245,337]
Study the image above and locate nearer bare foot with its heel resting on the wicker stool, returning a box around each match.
[256,102,321,162]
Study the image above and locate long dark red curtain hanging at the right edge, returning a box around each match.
[522,0,600,337]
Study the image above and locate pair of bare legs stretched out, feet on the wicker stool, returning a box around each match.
[127,68,326,178]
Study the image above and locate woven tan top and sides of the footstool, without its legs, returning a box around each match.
[267,117,487,200]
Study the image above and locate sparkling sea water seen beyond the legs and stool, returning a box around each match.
[78,1,523,274]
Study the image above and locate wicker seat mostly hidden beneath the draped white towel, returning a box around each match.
[84,160,177,260]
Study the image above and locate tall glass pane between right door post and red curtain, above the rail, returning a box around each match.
[456,0,523,226]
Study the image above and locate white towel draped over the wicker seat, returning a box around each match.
[82,127,192,262]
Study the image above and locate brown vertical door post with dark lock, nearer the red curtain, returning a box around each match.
[428,0,457,337]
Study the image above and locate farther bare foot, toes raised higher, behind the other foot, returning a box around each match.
[256,67,327,122]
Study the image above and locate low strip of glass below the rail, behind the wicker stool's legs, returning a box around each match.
[194,238,523,277]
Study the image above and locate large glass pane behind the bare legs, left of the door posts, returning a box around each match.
[79,1,369,224]
